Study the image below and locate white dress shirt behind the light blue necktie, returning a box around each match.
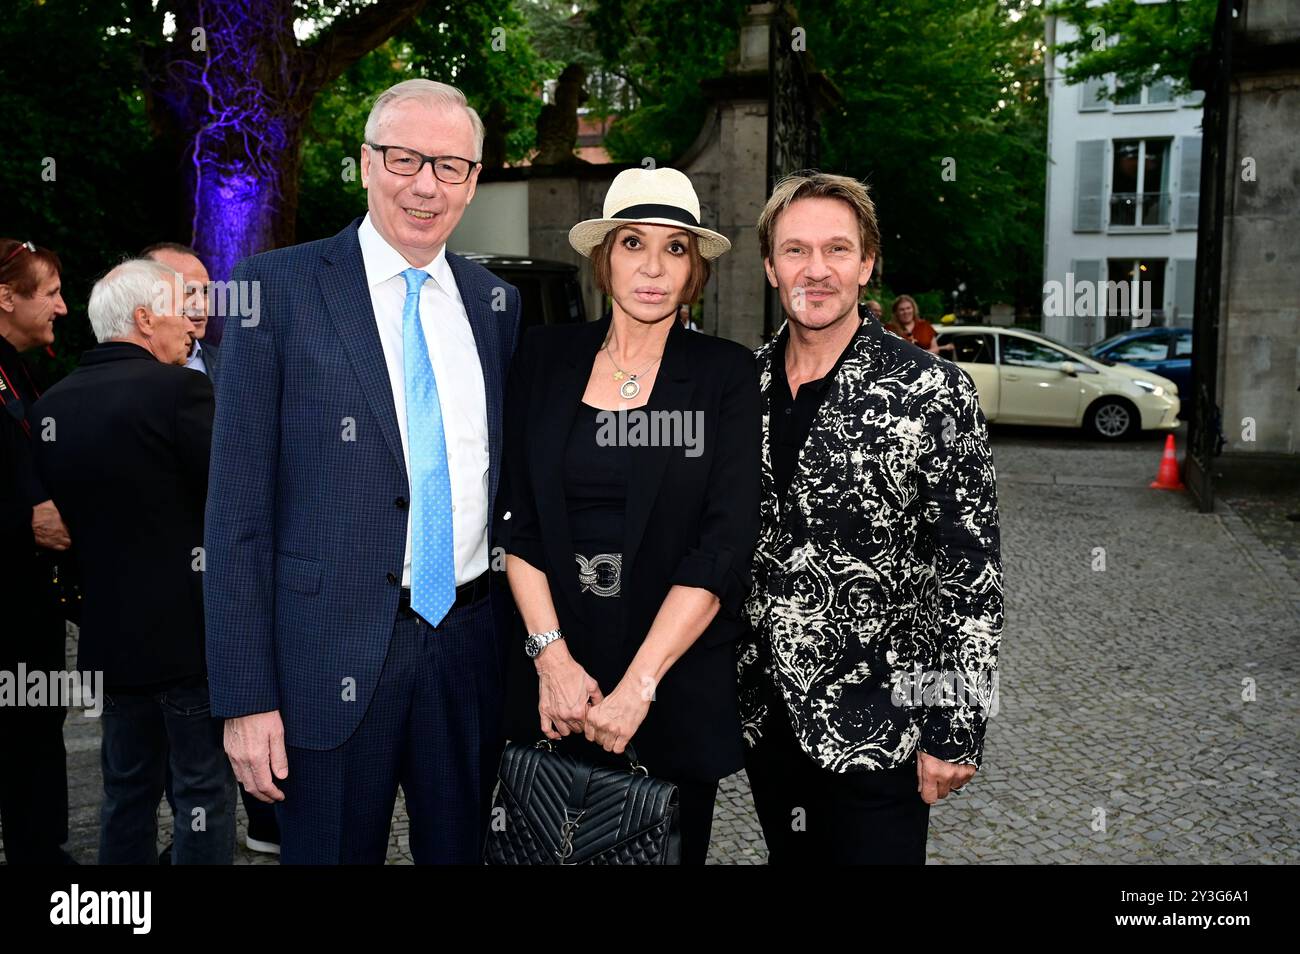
[358,214,489,586]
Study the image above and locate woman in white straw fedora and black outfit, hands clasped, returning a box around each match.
[502,169,762,864]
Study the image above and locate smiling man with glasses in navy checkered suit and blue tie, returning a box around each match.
[204,79,520,864]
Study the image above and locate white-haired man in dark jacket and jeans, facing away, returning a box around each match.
[29,259,235,864]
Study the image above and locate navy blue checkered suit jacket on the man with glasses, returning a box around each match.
[204,220,520,749]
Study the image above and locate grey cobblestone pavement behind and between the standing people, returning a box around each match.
[5,428,1300,864]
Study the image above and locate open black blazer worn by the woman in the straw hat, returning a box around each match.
[502,320,762,780]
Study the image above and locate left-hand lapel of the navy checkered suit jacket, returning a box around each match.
[319,220,406,473]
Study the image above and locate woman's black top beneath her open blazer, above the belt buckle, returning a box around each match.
[564,404,628,556]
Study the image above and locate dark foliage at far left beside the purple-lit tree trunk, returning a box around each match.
[0,0,172,372]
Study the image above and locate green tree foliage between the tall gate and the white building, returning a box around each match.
[800,0,1047,310]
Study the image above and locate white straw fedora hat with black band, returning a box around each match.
[569,169,731,259]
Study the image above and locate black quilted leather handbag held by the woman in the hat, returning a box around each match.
[484,740,681,864]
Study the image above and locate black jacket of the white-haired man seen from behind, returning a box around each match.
[30,342,212,690]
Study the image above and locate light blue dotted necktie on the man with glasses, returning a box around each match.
[402,268,456,626]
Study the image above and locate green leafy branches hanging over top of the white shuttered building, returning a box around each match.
[1052,0,1218,95]
